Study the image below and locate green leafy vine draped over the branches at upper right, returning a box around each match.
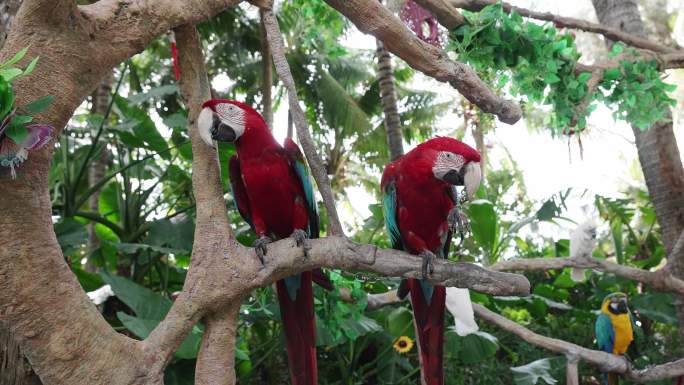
[451,3,674,134]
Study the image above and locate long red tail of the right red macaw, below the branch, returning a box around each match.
[408,279,446,385]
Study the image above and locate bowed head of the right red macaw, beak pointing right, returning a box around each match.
[414,136,482,199]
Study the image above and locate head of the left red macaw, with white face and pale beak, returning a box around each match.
[197,99,268,147]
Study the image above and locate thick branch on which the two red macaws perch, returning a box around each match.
[150,237,530,360]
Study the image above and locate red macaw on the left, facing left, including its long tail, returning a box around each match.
[197,99,332,385]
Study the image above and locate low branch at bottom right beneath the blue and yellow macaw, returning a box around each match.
[473,304,684,383]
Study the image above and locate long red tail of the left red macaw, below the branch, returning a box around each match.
[276,271,318,385]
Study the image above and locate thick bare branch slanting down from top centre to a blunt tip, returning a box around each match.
[326,0,522,124]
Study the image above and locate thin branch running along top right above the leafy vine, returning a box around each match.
[448,0,682,53]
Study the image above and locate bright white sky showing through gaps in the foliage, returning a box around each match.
[214,0,684,237]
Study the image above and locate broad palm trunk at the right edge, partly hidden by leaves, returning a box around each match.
[592,0,684,348]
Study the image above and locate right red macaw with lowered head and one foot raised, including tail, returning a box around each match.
[381,137,481,385]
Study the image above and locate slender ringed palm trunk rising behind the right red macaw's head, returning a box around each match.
[375,40,404,161]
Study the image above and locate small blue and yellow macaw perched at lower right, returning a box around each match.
[595,293,634,385]
